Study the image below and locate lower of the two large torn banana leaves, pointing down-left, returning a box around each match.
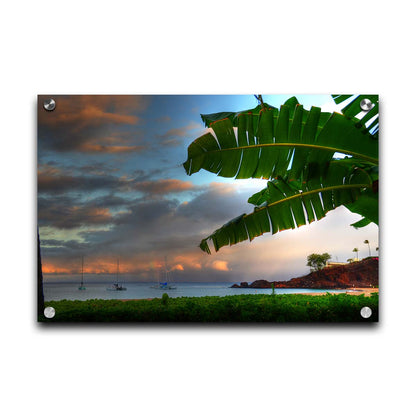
[200,164,377,254]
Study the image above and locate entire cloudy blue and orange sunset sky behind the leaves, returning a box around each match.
[38,95,378,282]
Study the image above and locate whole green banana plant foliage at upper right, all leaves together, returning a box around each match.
[183,95,378,253]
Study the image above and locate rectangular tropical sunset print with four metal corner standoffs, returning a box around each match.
[38,94,378,324]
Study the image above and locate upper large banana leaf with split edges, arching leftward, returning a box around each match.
[183,97,378,180]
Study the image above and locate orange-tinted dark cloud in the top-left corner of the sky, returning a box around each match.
[38,95,150,153]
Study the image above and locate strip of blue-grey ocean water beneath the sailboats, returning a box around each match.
[43,282,345,301]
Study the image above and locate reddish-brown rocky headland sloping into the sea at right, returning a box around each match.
[231,257,378,289]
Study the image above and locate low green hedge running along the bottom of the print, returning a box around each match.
[39,293,378,323]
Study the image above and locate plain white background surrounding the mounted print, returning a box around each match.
[0,0,416,416]
